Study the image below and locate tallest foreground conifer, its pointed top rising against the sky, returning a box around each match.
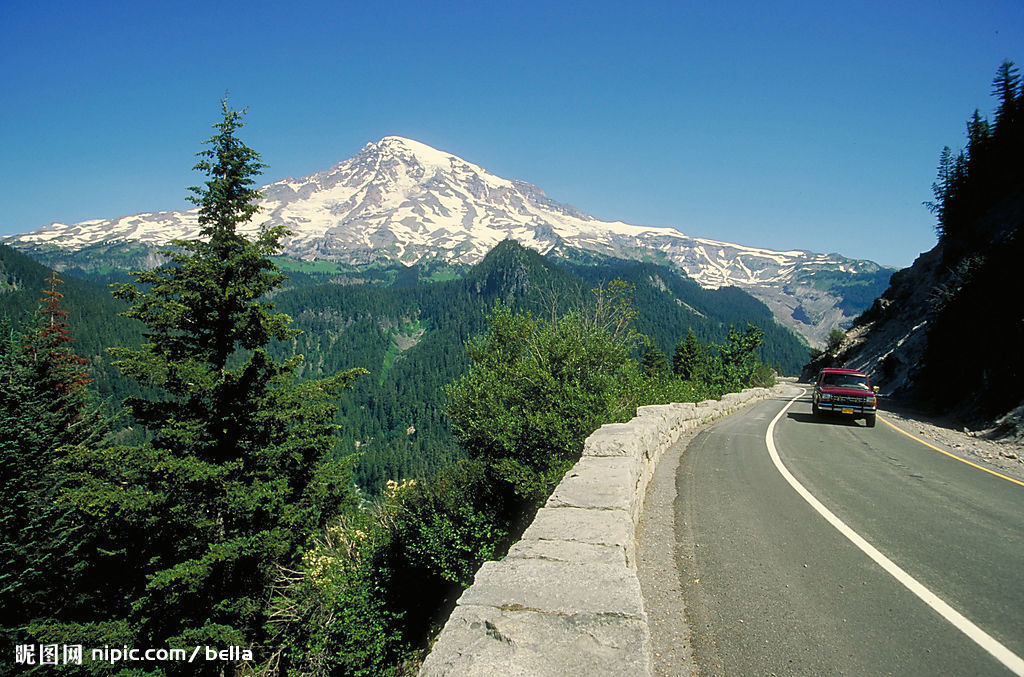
[59,101,361,670]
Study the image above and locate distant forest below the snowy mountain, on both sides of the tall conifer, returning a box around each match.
[0,241,808,495]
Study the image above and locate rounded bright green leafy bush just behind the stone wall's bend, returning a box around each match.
[445,304,635,499]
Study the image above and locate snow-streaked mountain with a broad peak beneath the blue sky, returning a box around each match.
[5,136,881,343]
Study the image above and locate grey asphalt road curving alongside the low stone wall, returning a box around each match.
[675,388,1024,676]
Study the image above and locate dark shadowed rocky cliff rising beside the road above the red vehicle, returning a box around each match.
[804,197,1024,436]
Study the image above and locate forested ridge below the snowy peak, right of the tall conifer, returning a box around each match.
[274,241,808,493]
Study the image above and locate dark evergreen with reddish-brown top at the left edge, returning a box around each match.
[0,273,103,643]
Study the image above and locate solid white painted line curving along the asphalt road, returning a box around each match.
[765,389,1024,677]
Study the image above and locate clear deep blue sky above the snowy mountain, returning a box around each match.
[0,0,1024,266]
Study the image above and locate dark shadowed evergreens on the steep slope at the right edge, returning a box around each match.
[918,61,1024,416]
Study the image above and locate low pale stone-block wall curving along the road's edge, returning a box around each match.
[420,386,778,677]
